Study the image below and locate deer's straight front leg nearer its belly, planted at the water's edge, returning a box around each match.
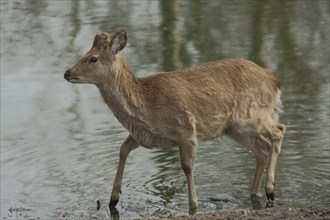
[179,141,198,214]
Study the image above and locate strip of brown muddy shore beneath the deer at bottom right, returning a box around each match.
[161,207,330,220]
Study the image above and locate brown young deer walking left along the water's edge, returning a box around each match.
[64,29,285,210]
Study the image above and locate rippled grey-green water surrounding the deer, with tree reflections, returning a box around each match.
[0,0,330,219]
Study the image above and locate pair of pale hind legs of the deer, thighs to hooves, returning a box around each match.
[227,115,285,200]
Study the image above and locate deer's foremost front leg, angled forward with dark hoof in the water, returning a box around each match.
[109,135,139,207]
